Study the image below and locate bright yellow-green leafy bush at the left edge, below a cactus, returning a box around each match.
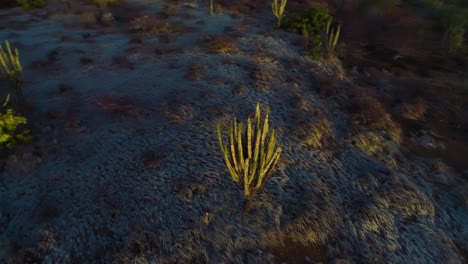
[0,95,32,155]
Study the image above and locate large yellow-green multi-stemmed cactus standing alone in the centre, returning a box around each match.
[217,103,282,212]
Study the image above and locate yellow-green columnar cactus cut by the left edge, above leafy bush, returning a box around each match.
[0,40,24,104]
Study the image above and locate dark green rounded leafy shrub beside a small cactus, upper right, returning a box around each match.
[280,5,331,58]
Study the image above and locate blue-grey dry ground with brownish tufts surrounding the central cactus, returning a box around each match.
[0,1,468,263]
